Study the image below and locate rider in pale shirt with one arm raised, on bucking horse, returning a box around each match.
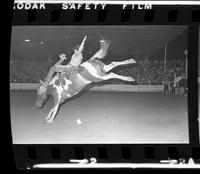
[44,36,87,88]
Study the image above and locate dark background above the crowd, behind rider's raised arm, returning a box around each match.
[11,25,187,62]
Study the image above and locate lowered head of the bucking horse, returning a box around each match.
[36,80,47,108]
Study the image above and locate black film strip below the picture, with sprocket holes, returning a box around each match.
[14,144,200,169]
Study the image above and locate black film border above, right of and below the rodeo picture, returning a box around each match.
[10,1,200,169]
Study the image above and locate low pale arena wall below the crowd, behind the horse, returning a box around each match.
[10,83,163,92]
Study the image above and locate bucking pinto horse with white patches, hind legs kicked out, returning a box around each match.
[36,40,136,124]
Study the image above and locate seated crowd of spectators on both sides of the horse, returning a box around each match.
[10,59,185,85]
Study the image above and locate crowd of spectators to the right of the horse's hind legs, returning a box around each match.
[113,57,185,85]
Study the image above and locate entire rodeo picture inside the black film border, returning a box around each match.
[10,25,189,144]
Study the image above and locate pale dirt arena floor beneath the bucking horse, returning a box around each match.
[10,91,189,144]
